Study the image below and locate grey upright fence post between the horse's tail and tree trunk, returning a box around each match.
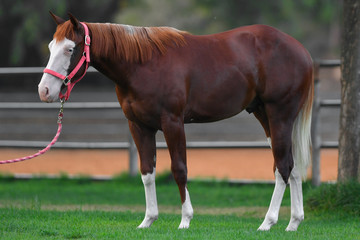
[311,63,321,186]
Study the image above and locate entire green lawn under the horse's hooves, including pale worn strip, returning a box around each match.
[0,175,360,239]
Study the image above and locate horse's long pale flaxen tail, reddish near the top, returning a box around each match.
[292,72,314,179]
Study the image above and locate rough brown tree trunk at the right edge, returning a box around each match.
[338,0,360,182]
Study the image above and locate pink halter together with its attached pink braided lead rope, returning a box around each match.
[0,22,91,164]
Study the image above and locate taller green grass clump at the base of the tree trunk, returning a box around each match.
[306,181,360,216]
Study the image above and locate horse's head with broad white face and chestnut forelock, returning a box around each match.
[39,12,86,102]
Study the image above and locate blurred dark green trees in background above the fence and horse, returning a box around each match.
[0,0,341,66]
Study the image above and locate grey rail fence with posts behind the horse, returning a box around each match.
[0,60,340,186]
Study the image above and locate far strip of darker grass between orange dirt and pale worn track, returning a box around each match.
[0,175,296,207]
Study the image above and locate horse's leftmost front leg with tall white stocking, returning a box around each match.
[129,121,159,228]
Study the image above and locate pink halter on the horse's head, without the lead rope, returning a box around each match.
[44,22,91,101]
